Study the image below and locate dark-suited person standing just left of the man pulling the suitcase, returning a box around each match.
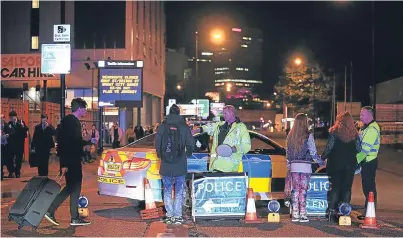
[31,114,55,176]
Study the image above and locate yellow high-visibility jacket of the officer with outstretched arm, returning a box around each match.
[202,121,251,172]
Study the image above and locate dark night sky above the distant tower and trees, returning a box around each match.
[166,1,403,104]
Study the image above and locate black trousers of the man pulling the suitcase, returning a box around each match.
[48,164,83,219]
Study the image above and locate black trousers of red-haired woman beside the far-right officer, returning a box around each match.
[328,169,355,211]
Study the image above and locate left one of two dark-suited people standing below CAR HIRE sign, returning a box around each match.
[8,111,28,178]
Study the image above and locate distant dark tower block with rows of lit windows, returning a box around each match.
[190,27,263,98]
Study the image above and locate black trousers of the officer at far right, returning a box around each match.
[361,158,378,210]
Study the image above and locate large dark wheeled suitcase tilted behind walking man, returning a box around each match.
[8,176,62,230]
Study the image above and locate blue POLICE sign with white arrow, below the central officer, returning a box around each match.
[192,176,248,217]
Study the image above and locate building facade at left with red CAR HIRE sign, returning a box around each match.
[1,0,166,125]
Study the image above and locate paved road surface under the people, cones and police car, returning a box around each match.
[1,134,403,237]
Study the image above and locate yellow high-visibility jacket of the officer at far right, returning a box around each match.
[357,121,381,163]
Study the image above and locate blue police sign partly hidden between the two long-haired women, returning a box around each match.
[306,175,330,216]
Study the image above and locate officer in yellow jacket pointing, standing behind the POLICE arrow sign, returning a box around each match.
[193,105,251,173]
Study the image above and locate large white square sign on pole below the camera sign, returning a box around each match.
[41,44,71,74]
